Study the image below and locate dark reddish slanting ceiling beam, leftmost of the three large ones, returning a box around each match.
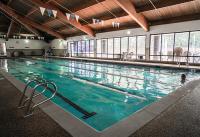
[0,2,64,39]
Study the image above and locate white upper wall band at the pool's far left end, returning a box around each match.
[0,39,48,49]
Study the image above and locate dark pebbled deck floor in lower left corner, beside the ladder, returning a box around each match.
[0,76,72,137]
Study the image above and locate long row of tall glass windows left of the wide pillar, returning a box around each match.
[70,36,146,60]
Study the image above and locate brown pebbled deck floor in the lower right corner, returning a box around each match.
[130,82,200,137]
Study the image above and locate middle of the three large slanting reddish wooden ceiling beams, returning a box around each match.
[32,0,95,37]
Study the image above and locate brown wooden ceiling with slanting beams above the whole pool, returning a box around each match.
[0,0,200,38]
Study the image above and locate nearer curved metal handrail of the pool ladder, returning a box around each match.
[25,81,57,117]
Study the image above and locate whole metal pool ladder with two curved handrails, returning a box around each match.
[18,79,57,117]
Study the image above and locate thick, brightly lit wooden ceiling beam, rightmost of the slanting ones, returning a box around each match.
[114,0,149,31]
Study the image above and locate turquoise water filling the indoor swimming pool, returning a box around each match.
[0,58,200,131]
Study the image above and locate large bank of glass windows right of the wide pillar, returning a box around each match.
[150,31,200,63]
